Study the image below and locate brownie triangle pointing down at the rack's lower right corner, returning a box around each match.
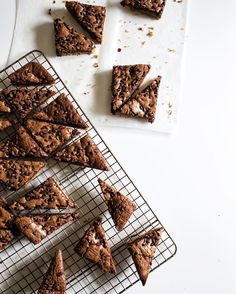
[128,228,163,285]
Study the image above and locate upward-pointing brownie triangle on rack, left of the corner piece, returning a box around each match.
[75,217,116,274]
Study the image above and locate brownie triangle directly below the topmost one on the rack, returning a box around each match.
[2,89,55,118]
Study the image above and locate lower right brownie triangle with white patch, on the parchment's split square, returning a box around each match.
[118,76,161,123]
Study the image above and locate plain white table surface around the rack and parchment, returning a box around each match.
[0,0,236,294]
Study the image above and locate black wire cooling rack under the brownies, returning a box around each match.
[0,50,177,294]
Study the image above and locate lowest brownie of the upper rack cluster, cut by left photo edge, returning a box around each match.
[0,160,46,190]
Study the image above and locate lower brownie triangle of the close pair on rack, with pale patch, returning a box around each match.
[15,213,79,244]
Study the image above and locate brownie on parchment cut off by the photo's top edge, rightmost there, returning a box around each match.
[121,0,166,19]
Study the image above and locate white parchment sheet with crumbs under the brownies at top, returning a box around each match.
[9,0,187,133]
